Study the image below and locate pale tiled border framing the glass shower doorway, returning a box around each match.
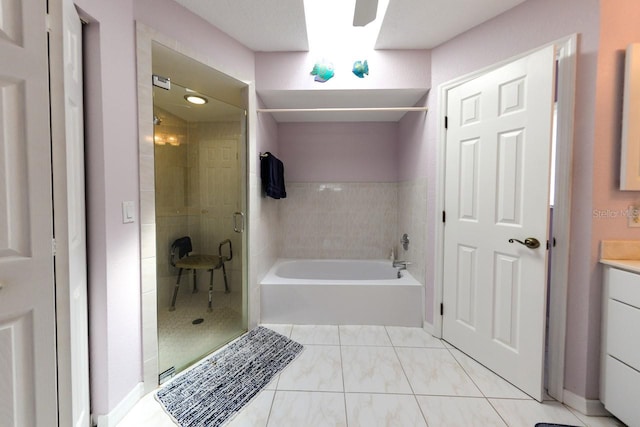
[136,22,255,396]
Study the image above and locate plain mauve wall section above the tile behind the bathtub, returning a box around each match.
[278,122,399,182]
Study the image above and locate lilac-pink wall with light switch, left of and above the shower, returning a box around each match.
[76,0,254,415]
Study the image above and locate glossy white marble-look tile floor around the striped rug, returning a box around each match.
[118,325,623,427]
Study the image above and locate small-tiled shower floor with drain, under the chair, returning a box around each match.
[158,290,246,372]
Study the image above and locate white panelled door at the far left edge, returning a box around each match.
[0,0,58,427]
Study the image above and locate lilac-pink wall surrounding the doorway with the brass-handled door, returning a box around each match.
[427,0,604,399]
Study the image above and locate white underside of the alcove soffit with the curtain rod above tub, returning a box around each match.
[257,89,427,122]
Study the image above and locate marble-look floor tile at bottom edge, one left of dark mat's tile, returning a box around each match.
[416,396,508,427]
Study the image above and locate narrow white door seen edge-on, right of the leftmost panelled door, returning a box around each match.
[54,0,91,427]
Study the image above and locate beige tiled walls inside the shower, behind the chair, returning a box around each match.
[154,112,242,308]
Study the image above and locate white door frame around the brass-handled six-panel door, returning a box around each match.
[433,34,578,402]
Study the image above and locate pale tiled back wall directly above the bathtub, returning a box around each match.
[279,182,398,259]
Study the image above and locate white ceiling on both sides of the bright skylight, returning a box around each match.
[176,0,525,52]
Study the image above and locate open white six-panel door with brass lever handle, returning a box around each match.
[443,46,555,400]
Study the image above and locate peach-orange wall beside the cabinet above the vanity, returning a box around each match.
[592,0,640,394]
